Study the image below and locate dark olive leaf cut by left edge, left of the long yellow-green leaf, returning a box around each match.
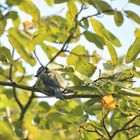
[0,46,14,63]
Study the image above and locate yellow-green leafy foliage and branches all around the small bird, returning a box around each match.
[0,0,140,140]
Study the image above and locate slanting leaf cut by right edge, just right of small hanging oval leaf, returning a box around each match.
[124,10,140,24]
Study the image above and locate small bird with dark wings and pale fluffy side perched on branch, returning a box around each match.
[35,67,64,100]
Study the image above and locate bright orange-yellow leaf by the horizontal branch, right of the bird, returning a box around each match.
[102,95,116,110]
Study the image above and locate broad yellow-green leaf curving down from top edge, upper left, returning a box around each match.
[18,0,40,23]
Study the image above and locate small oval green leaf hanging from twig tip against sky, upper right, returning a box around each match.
[114,11,124,26]
